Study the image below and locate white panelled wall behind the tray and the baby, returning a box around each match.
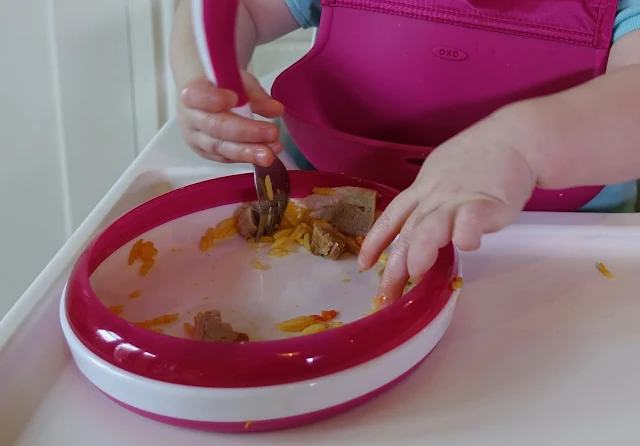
[0,0,311,318]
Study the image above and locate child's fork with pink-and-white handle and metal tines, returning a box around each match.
[191,0,291,241]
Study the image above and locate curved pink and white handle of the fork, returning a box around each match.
[191,0,253,118]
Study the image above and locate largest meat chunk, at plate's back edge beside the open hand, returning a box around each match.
[304,186,378,237]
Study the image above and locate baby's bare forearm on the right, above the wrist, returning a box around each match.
[504,30,640,189]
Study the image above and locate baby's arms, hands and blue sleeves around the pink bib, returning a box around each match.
[171,0,640,300]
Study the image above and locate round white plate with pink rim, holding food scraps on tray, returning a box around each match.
[60,171,461,432]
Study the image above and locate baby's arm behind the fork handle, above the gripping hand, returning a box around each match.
[170,0,300,91]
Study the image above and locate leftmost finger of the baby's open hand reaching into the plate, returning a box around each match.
[358,189,418,269]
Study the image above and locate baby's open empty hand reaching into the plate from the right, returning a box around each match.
[359,110,536,302]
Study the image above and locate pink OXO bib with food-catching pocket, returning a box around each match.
[273,0,617,211]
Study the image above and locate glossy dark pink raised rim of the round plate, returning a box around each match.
[65,171,458,388]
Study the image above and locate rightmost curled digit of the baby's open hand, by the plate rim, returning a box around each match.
[452,198,511,251]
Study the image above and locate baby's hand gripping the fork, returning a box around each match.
[178,72,284,166]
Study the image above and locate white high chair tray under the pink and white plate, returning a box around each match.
[0,118,640,446]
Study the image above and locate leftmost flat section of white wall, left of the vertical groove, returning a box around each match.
[0,0,70,315]
